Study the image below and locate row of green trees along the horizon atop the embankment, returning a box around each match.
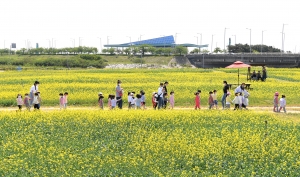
[0,44,291,55]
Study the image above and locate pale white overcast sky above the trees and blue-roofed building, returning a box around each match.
[0,0,300,53]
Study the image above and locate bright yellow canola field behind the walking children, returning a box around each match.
[0,68,300,107]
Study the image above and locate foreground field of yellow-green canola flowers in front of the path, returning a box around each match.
[0,110,300,176]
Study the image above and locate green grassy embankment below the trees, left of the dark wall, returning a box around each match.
[0,55,173,70]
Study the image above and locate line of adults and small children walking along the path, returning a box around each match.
[16,80,286,112]
